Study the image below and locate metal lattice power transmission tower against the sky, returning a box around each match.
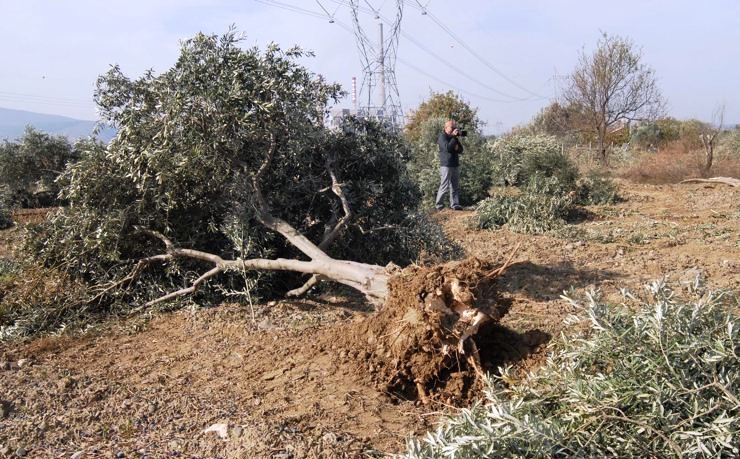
[349,0,404,128]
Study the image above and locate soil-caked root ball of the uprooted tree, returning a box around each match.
[339,258,508,405]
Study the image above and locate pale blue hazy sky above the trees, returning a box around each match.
[0,0,740,134]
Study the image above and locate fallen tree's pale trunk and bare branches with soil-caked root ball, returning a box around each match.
[130,226,522,404]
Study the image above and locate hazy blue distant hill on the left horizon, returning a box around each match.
[0,108,115,142]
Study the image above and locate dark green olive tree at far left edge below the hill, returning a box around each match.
[0,127,81,208]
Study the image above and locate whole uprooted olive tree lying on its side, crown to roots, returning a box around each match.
[27,31,516,402]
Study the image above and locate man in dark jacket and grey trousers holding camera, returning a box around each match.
[435,120,467,210]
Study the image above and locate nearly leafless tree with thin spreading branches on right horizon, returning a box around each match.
[563,34,664,163]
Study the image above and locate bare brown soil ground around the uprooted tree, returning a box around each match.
[0,183,740,458]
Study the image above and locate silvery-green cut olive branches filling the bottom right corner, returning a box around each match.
[404,282,740,459]
